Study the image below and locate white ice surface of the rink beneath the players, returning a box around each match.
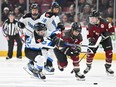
[0,57,116,87]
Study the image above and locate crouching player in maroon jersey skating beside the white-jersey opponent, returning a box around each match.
[53,22,85,80]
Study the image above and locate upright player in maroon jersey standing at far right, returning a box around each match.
[84,10,115,74]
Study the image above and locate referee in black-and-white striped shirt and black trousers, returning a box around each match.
[2,12,22,59]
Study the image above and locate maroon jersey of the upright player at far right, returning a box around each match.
[87,18,115,42]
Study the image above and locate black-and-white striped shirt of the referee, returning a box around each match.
[2,19,20,36]
